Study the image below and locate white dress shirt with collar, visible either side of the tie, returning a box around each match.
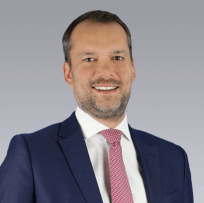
[75,106,147,203]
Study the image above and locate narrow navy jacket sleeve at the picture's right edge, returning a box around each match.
[181,148,193,203]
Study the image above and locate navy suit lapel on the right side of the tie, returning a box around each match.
[129,126,162,203]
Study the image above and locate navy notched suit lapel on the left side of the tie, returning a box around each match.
[59,112,102,203]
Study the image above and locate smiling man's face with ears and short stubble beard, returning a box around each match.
[63,21,135,120]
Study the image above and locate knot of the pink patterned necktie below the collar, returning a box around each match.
[100,129,122,144]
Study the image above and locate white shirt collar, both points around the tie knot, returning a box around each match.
[75,106,131,140]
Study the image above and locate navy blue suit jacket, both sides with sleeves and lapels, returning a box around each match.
[0,113,193,203]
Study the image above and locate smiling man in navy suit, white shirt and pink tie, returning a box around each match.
[0,11,193,203]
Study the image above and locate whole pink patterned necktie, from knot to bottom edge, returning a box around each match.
[100,129,133,203]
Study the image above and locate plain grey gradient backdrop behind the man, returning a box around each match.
[0,0,204,202]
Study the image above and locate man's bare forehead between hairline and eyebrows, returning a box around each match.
[70,20,128,52]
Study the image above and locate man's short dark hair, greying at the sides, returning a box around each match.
[62,10,132,68]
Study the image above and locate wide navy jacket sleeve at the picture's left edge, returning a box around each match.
[0,135,35,203]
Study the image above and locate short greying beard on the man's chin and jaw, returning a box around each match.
[74,83,131,121]
